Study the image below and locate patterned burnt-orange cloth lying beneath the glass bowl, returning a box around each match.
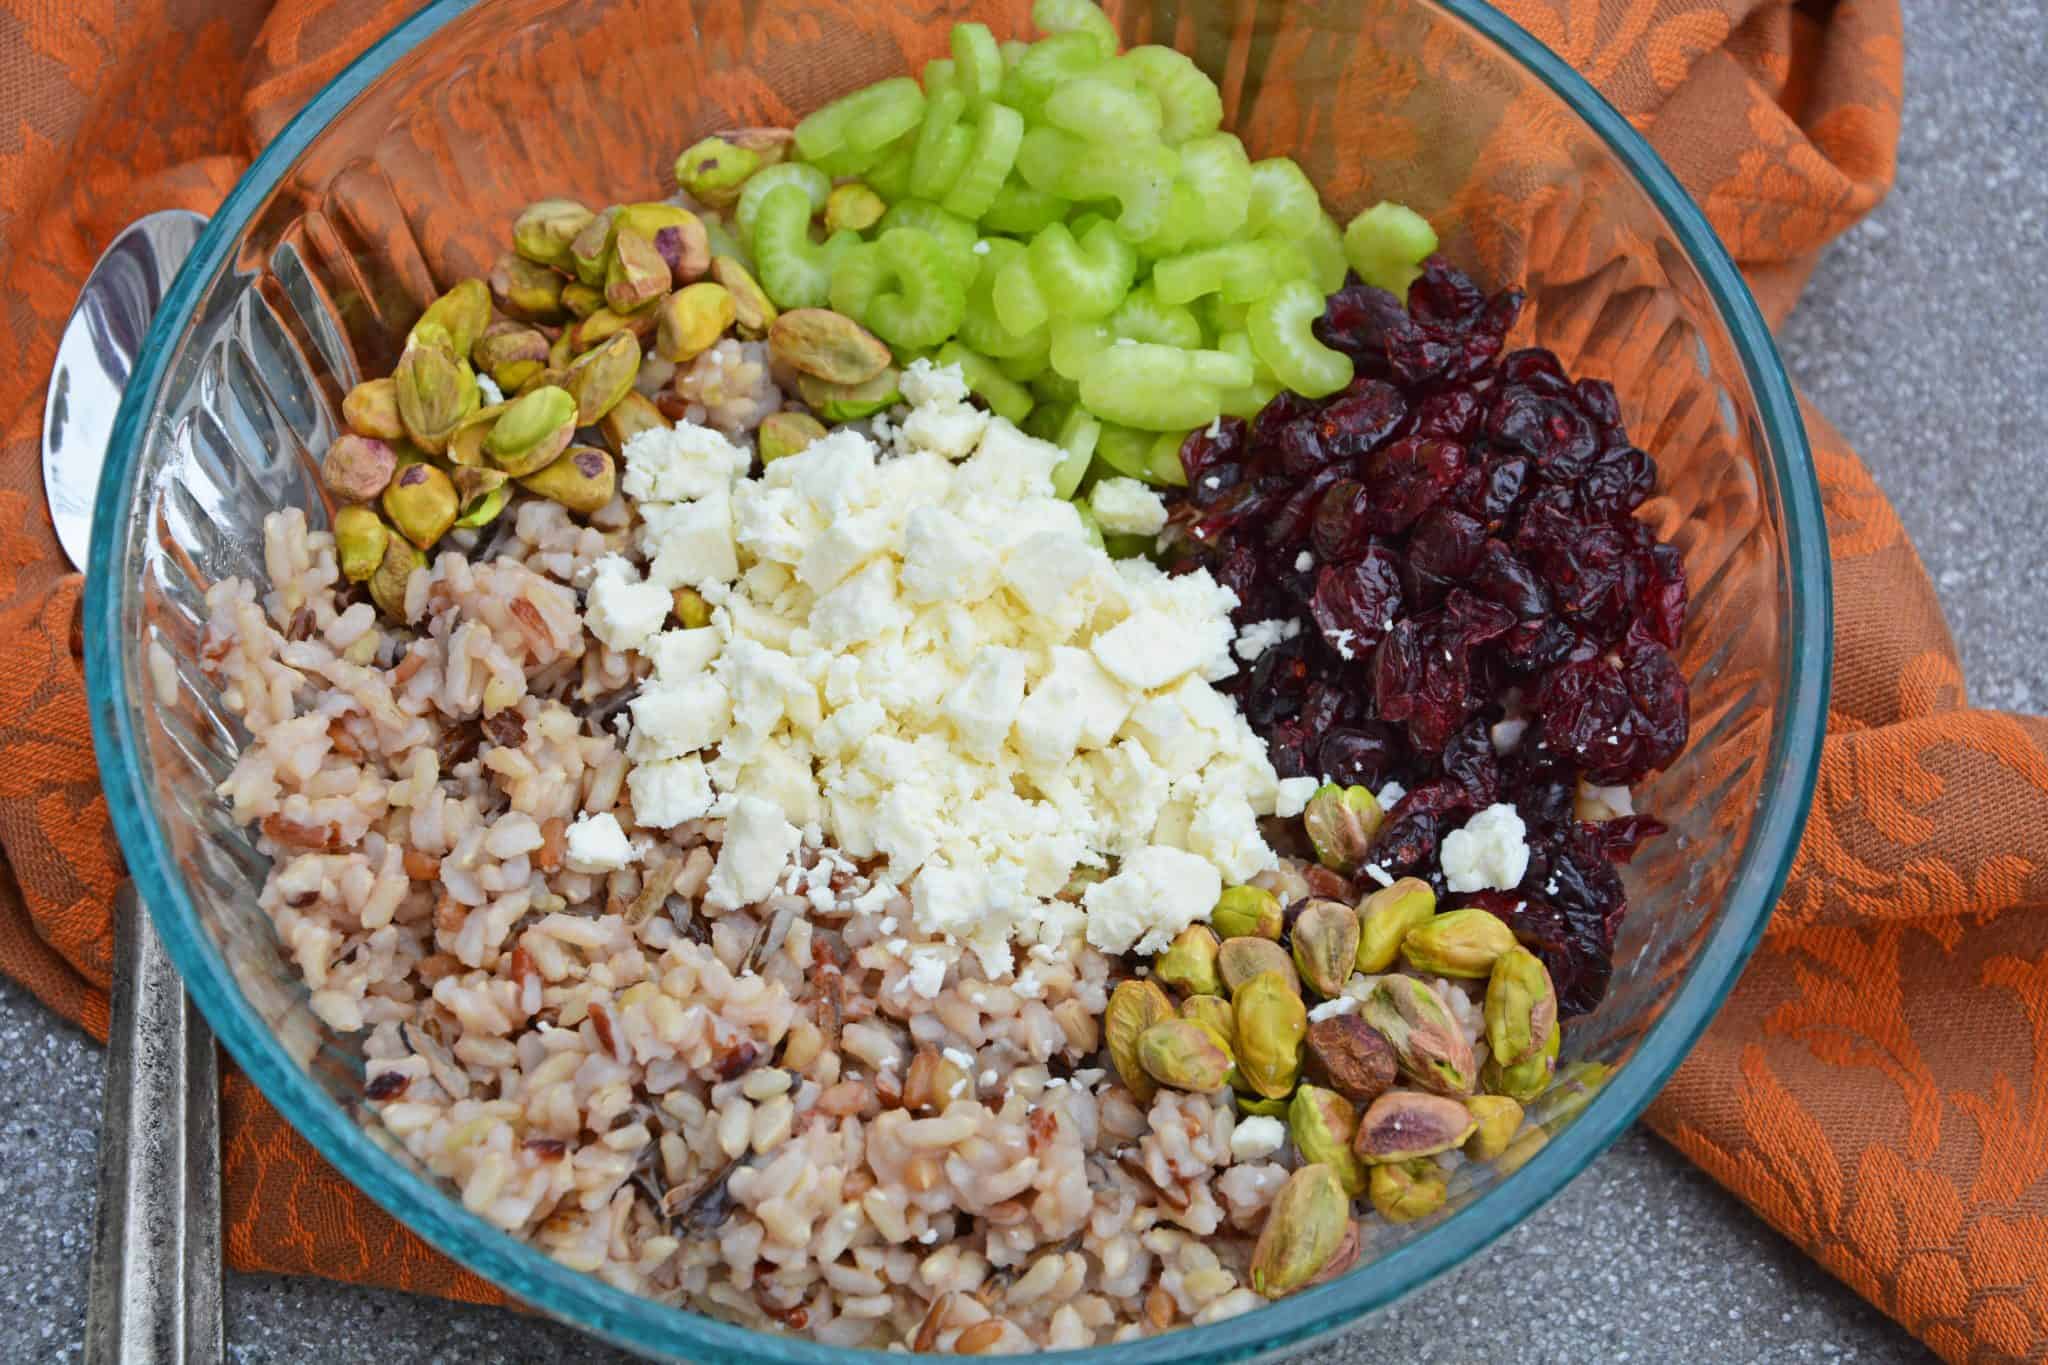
[0,0,2048,1361]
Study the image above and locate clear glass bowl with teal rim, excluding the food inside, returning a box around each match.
[84,0,1829,1363]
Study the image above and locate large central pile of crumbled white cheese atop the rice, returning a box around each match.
[610,362,1277,965]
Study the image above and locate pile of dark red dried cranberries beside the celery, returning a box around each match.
[1174,258,1688,1015]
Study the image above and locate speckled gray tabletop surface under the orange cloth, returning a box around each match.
[0,0,2048,1365]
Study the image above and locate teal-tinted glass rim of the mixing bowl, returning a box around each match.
[84,0,1833,1365]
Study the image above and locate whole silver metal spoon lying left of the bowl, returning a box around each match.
[43,209,223,1365]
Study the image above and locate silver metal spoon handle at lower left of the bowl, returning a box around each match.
[84,882,223,1365]
